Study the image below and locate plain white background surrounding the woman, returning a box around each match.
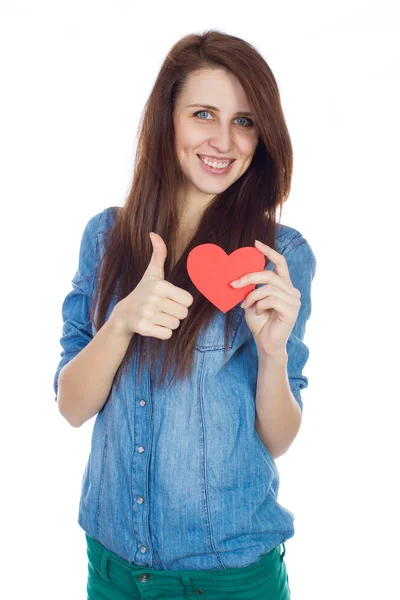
[0,0,400,600]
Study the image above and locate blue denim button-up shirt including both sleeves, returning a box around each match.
[54,208,316,570]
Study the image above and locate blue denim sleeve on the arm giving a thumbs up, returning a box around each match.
[53,213,103,401]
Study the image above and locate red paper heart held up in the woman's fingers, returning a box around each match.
[186,244,265,313]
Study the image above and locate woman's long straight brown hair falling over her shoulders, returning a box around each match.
[91,31,293,392]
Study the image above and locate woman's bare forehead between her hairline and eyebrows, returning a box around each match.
[178,69,251,112]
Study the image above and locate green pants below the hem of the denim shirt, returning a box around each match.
[85,533,290,600]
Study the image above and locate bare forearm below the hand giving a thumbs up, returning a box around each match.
[57,315,132,427]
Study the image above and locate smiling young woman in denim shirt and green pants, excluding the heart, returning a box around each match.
[54,31,316,600]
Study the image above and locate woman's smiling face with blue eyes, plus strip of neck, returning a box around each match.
[173,69,258,225]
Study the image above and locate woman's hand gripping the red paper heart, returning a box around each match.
[231,240,301,357]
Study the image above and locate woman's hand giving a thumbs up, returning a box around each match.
[110,232,193,340]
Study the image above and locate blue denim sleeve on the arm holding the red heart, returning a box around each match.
[283,234,317,412]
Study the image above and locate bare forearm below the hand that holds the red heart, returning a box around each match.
[255,354,302,458]
